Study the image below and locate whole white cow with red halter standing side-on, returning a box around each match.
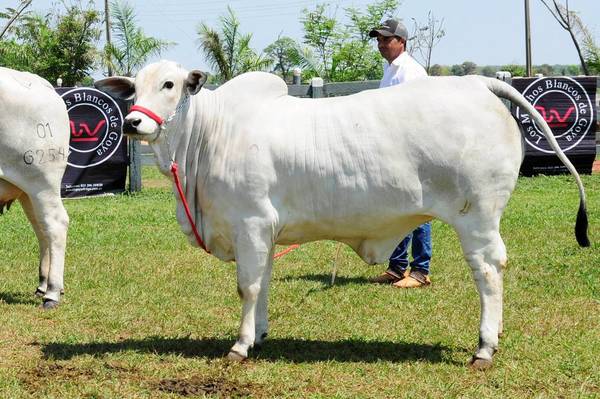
[96,61,589,367]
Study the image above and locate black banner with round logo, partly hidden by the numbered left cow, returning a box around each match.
[56,87,128,197]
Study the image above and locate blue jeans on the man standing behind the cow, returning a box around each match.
[388,222,431,277]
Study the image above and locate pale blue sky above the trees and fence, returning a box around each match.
[25,0,600,76]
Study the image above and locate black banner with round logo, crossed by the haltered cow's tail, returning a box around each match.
[512,76,597,176]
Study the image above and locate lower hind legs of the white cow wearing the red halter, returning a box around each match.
[455,215,507,369]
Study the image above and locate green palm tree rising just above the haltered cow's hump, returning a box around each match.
[197,7,272,82]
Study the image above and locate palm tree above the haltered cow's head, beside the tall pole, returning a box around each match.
[102,0,174,76]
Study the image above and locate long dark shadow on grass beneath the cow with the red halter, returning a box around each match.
[42,337,460,363]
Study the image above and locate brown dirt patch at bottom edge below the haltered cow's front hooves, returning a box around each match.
[153,377,260,398]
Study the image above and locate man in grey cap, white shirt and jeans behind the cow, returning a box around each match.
[369,19,431,288]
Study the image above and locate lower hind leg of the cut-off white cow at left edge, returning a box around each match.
[20,193,69,309]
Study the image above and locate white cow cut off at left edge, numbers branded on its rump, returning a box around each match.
[0,68,70,309]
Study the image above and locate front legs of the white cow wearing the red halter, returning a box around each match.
[228,224,273,360]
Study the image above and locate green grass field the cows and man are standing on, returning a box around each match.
[0,168,600,398]
